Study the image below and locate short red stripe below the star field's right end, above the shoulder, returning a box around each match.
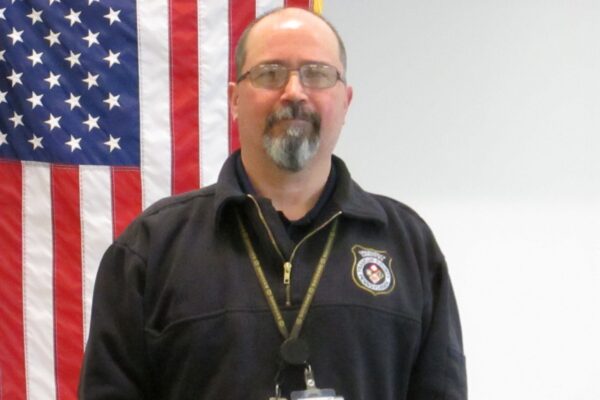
[111,167,142,237]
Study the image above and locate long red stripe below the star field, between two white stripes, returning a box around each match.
[51,165,83,400]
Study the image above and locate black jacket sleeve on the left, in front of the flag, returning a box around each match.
[79,244,149,400]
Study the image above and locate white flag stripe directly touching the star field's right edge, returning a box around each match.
[137,0,171,208]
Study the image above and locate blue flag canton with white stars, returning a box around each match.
[0,0,140,166]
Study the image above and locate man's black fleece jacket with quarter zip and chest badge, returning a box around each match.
[79,155,467,400]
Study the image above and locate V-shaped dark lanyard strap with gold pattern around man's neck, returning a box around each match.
[236,212,338,339]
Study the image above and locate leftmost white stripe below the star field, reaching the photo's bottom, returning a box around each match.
[23,163,56,399]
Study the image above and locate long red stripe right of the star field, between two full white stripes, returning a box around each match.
[169,0,200,193]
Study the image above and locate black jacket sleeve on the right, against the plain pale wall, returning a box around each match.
[408,238,467,400]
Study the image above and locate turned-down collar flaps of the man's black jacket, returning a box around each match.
[214,150,387,226]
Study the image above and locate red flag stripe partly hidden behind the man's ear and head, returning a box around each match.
[229,0,256,152]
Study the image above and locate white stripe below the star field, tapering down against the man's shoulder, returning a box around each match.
[79,166,113,341]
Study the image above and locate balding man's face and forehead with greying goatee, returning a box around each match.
[230,9,352,171]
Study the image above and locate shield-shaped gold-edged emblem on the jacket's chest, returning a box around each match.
[352,245,396,296]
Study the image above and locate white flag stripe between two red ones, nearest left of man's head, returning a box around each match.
[198,1,229,186]
